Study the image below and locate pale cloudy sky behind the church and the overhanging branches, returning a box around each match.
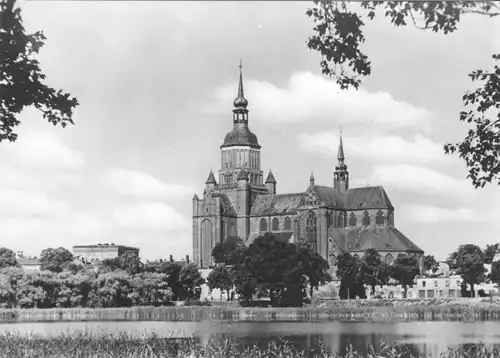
[5,1,500,260]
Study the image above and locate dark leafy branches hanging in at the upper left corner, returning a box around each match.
[0,0,78,142]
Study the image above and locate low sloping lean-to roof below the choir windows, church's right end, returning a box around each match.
[329,226,423,253]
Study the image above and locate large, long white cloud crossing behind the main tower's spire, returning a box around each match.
[204,72,431,129]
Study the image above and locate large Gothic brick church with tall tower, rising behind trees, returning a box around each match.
[193,66,423,274]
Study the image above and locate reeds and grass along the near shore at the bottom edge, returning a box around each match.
[0,333,500,358]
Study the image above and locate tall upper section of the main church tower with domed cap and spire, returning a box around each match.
[219,63,265,188]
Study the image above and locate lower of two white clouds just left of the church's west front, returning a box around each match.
[114,202,189,230]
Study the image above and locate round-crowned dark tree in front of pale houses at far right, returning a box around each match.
[448,244,486,297]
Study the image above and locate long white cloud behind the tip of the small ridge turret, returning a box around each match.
[297,132,452,164]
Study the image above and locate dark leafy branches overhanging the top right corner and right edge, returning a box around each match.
[306,0,500,188]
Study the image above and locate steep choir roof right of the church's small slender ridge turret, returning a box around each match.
[344,186,394,210]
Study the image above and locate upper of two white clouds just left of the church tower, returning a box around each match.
[105,168,194,198]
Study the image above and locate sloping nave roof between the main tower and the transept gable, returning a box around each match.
[250,193,304,216]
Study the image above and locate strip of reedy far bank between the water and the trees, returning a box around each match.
[0,298,500,323]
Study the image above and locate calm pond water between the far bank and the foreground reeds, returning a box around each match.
[0,321,500,357]
